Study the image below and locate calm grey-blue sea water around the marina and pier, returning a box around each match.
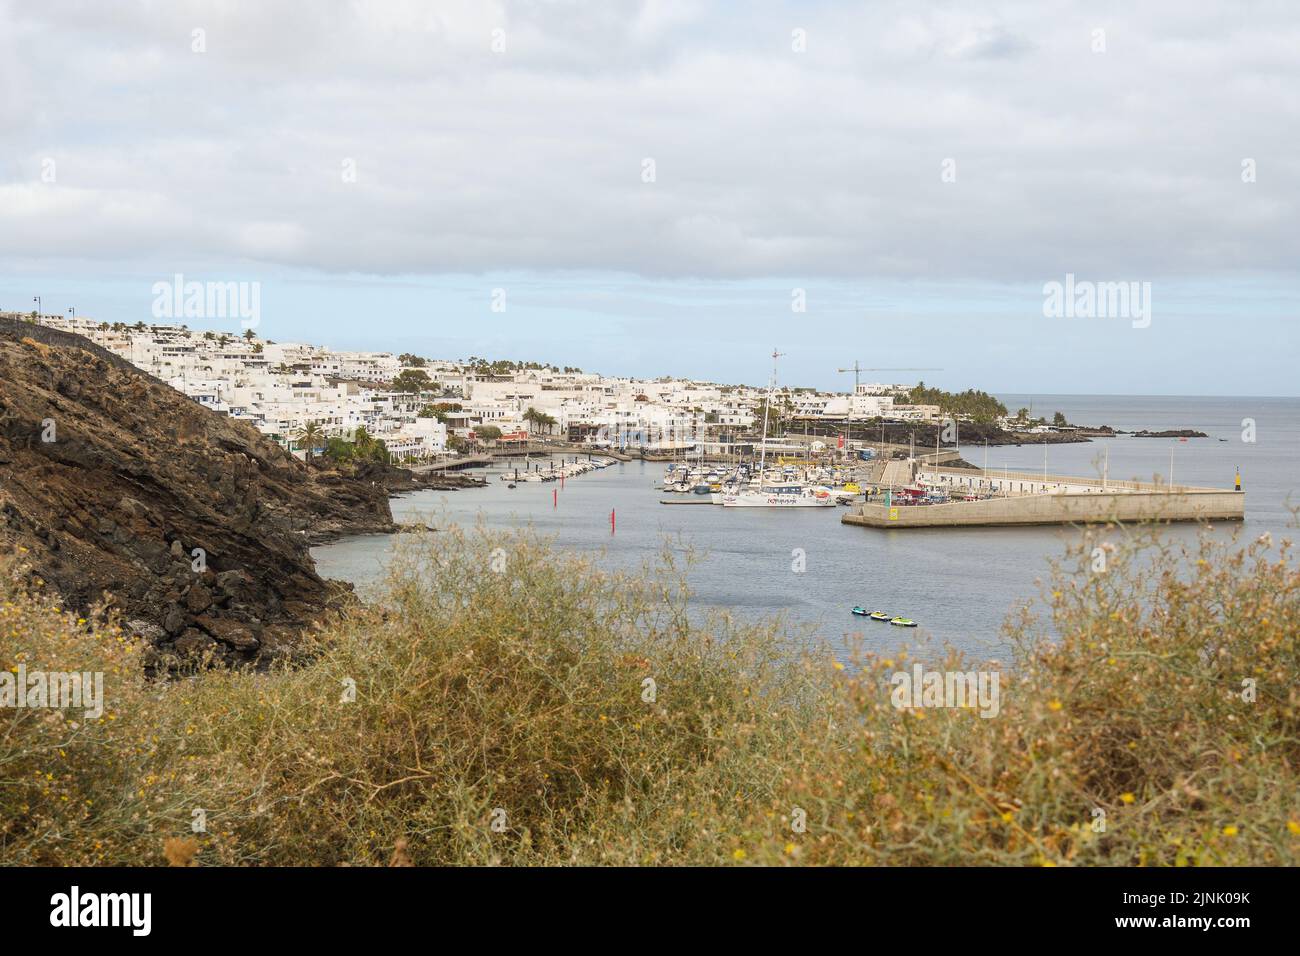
[312,397,1300,656]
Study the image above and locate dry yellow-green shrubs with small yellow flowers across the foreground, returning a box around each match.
[0,522,1300,865]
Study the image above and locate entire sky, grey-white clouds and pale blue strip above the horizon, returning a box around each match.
[0,0,1300,395]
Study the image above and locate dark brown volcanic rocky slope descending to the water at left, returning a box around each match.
[0,324,393,662]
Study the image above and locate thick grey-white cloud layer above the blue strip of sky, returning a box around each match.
[0,0,1300,281]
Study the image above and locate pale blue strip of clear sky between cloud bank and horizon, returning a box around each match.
[0,272,1300,395]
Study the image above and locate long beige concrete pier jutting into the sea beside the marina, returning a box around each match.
[840,468,1245,528]
